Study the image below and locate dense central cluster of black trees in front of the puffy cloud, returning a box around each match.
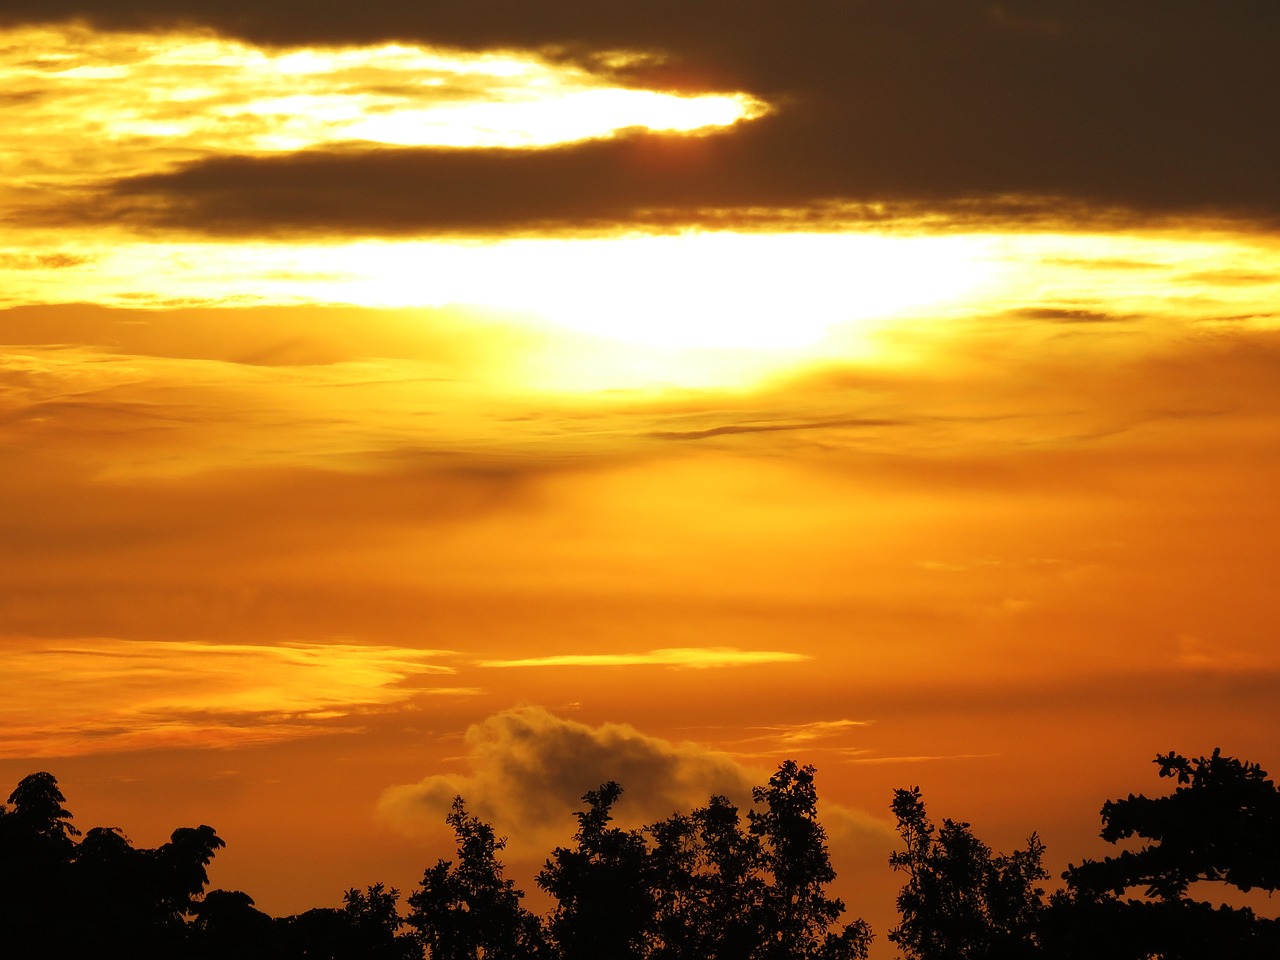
[538,760,870,960]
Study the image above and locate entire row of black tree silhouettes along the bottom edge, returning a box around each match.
[0,750,1280,960]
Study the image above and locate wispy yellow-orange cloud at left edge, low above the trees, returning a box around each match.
[0,637,476,758]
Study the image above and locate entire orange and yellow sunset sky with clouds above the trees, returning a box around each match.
[0,0,1280,956]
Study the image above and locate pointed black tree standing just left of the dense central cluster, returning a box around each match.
[408,796,541,960]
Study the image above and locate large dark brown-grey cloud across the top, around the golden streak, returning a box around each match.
[6,0,1280,232]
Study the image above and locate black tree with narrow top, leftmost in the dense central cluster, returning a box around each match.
[538,781,654,960]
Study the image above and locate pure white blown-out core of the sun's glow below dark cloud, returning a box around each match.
[322,232,991,348]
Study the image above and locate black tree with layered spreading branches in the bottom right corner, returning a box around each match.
[1048,750,1280,960]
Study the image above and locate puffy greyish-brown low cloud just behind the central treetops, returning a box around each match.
[379,707,887,858]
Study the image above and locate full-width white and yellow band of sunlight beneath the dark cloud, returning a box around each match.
[0,232,1280,390]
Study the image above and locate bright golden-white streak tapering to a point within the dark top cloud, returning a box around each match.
[0,24,765,187]
